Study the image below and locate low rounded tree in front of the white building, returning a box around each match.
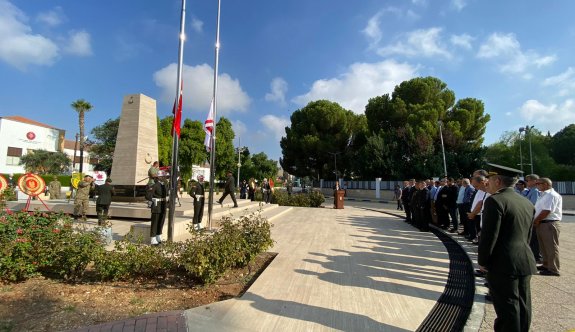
[20,150,70,174]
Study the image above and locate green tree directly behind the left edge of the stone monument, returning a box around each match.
[86,117,120,174]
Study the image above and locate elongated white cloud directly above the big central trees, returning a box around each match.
[292,60,417,113]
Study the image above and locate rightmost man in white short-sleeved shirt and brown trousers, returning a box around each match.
[533,178,563,276]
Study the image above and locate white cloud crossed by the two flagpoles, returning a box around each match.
[154,63,251,116]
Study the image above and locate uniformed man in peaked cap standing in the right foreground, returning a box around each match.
[477,164,537,331]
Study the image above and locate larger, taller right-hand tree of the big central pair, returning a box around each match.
[362,77,490,178]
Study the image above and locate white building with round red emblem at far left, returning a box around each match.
[0,116,93,174]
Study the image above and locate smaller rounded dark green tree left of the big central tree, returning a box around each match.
[280,100,365,179]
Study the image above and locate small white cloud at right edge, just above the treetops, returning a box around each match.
[519,99,575,132]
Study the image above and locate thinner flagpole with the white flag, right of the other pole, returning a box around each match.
[208,0,221,229]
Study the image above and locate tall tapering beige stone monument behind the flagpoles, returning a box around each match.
[111,94,158,201]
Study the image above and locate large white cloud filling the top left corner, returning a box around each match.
[0,0,59,70]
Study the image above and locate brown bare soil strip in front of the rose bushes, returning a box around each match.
[0,253,275,332]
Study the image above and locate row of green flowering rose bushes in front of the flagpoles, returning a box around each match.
[0,212,273,284]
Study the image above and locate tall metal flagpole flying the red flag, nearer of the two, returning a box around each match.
[168,0,186,241]
